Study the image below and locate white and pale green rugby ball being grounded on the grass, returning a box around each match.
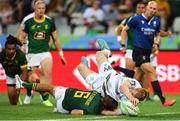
[120,100,140,116]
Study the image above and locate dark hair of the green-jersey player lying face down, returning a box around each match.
[101,95,118,111]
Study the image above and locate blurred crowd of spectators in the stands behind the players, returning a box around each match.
[0,0,180,34]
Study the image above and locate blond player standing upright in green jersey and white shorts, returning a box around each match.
[18,0,66,106]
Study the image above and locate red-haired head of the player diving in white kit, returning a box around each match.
[130,88,148,101]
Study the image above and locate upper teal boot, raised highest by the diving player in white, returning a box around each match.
[97,39,112,57]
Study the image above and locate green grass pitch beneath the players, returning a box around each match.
[0,93,180,121]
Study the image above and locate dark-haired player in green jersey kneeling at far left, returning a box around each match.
[0,35,28,105]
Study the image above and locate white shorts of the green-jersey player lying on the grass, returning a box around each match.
[54,86,69,113]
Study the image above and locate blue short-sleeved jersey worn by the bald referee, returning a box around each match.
[127,14,160,49]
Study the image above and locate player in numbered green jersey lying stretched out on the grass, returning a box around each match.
[16,76,121,115]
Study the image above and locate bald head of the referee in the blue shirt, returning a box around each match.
[145,1,158,19]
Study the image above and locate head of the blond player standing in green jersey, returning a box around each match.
[33,0,46,17]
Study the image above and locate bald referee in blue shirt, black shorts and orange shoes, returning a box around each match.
[121,1,176,106]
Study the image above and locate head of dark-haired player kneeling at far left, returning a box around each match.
[5,35,18,59]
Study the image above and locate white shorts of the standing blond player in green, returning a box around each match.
[26,52,52,69]
